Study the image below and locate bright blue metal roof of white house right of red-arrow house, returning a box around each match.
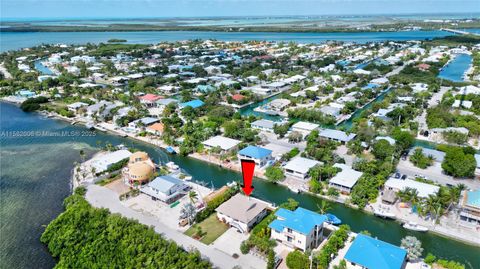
[268,207,327,234]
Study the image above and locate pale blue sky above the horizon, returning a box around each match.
[0,0,480,20]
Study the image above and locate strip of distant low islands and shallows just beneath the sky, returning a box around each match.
[1,16,480,33]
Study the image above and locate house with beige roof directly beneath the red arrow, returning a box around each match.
[215,193,268,233]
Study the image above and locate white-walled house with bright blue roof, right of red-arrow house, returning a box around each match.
[268,207,328,251]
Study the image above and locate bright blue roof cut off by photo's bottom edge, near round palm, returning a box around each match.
[345,234,407,269]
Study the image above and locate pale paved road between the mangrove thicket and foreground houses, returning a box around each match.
[86,185,266,268]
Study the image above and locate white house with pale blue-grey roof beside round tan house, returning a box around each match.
[140,175,190,203]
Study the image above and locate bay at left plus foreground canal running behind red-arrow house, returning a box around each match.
[0,103,480,268]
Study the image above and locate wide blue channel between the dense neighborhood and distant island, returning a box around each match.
[0,31,458,52]
